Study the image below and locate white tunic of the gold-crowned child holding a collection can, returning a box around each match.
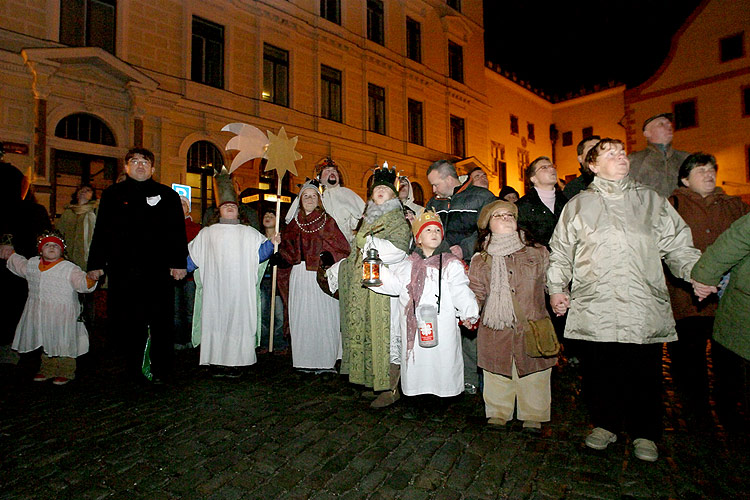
[372,260,479,397]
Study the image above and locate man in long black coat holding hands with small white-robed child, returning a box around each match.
[88,148,187,383]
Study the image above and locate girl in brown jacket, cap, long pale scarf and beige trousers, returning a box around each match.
[469,200,557,430]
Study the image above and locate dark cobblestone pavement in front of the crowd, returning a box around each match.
[0,326,750,500]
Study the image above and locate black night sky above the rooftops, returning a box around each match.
[484,0,700,97]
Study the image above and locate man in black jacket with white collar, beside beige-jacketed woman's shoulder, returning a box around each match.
[516,156,568,247]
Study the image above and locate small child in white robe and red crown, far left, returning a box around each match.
[0,231,96,385]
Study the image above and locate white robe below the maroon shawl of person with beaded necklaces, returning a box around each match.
[289,261,341,369]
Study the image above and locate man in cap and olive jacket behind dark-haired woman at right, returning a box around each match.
[628,113,690,198]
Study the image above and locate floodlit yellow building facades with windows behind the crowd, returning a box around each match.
[0,0,750,220]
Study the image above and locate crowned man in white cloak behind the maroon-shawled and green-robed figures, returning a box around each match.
[318,158,365,245]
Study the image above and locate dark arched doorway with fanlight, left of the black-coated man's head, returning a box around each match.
[50,113,119,217]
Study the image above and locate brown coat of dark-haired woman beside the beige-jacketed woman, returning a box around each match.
[667,187,750,319]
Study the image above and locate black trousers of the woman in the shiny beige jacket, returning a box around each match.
[581,341,663,441]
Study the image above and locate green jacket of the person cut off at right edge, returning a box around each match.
[692,214,750,360]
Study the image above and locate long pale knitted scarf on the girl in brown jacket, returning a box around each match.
[482,231,523,330]
